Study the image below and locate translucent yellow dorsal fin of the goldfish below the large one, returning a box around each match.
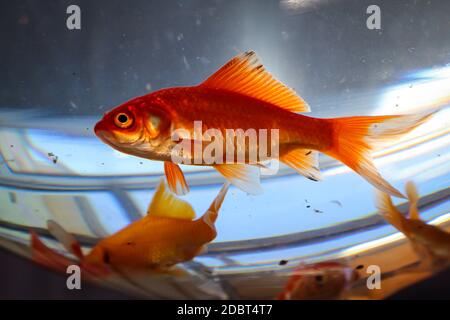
[147,180,195,220]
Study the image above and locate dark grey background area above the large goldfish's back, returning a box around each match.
[0,0,450,115]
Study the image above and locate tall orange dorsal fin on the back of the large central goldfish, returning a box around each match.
[200,51,310,112]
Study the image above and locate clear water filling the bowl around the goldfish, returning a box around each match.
[0,1,450,298]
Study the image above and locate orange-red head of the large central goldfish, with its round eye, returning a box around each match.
[94,97,170,158]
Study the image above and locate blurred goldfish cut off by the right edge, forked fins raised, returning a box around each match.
[376,181,450,270]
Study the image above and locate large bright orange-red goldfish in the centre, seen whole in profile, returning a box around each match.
[94,51,434,197]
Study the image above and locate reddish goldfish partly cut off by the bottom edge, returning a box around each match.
[277,262,358,300]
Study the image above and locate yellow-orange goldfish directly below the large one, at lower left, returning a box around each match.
[32,182,229,275]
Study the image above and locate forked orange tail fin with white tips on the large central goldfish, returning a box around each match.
[326,112,434,198]
